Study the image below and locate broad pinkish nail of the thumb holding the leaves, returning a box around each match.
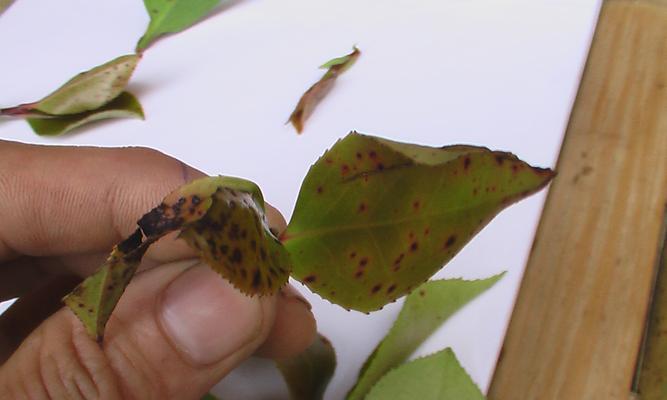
[158,264,262,365]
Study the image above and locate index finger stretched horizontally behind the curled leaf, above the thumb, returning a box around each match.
[0,141,203,262]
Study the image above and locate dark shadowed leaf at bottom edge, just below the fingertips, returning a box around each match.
[276,334,336,400]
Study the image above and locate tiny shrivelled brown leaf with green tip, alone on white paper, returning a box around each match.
[288,47,361,133]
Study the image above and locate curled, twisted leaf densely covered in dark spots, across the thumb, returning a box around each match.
[64,177,290,340]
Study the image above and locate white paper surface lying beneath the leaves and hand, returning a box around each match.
[0,0,599,400]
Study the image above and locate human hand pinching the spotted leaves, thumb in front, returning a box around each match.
[0,141,315,399]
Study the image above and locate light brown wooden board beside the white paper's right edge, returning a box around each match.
[489,0,667,400]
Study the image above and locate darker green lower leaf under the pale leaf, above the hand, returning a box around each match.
[27,92,144,136]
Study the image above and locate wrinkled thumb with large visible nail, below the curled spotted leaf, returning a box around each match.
[0,261,276,399]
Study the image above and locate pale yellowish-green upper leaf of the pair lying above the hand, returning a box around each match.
[33,54,140,115]
